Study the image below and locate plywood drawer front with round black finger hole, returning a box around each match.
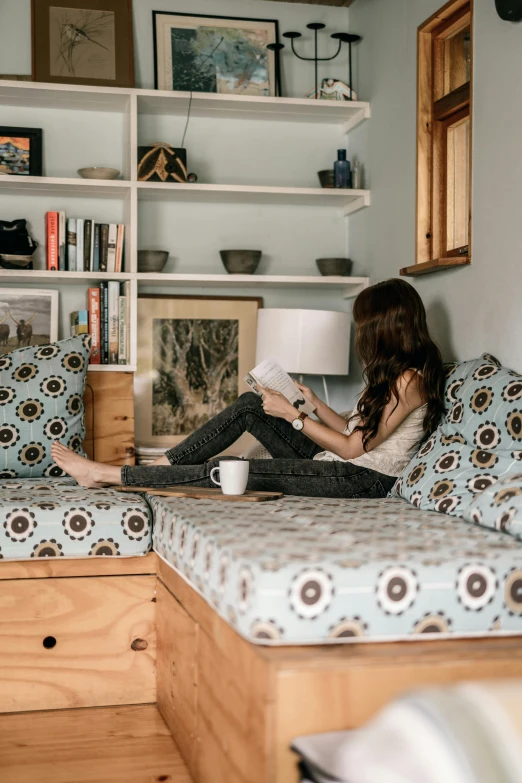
[0,576,156,712]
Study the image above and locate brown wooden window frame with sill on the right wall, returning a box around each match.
[401,0,473,275]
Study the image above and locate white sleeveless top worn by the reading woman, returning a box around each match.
[314,405,427,476]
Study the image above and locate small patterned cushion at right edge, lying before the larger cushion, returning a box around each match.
[465,473,522,539]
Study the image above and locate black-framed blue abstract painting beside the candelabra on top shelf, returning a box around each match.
[152,11,279,95]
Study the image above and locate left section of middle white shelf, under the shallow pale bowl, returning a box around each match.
[0,174,132,198]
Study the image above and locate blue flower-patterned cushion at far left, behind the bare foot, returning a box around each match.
[0,335,91,479]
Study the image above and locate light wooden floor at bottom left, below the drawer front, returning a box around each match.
[0,704,191,783]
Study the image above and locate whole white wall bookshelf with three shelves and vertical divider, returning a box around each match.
[0,80,370,372]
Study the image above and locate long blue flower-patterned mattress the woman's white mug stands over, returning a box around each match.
[149,497,522,645]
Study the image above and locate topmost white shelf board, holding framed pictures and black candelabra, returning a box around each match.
[0,80,370,131]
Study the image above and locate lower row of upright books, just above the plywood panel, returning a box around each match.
[71,280,131,364]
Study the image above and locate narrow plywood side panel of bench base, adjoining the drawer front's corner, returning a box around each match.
[156,582,198,777]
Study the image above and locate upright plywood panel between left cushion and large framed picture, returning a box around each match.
[84,372,134,465]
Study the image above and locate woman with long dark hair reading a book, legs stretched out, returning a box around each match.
[52,279,444,498]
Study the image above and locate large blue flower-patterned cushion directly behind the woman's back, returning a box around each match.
[392,354,522,516]
